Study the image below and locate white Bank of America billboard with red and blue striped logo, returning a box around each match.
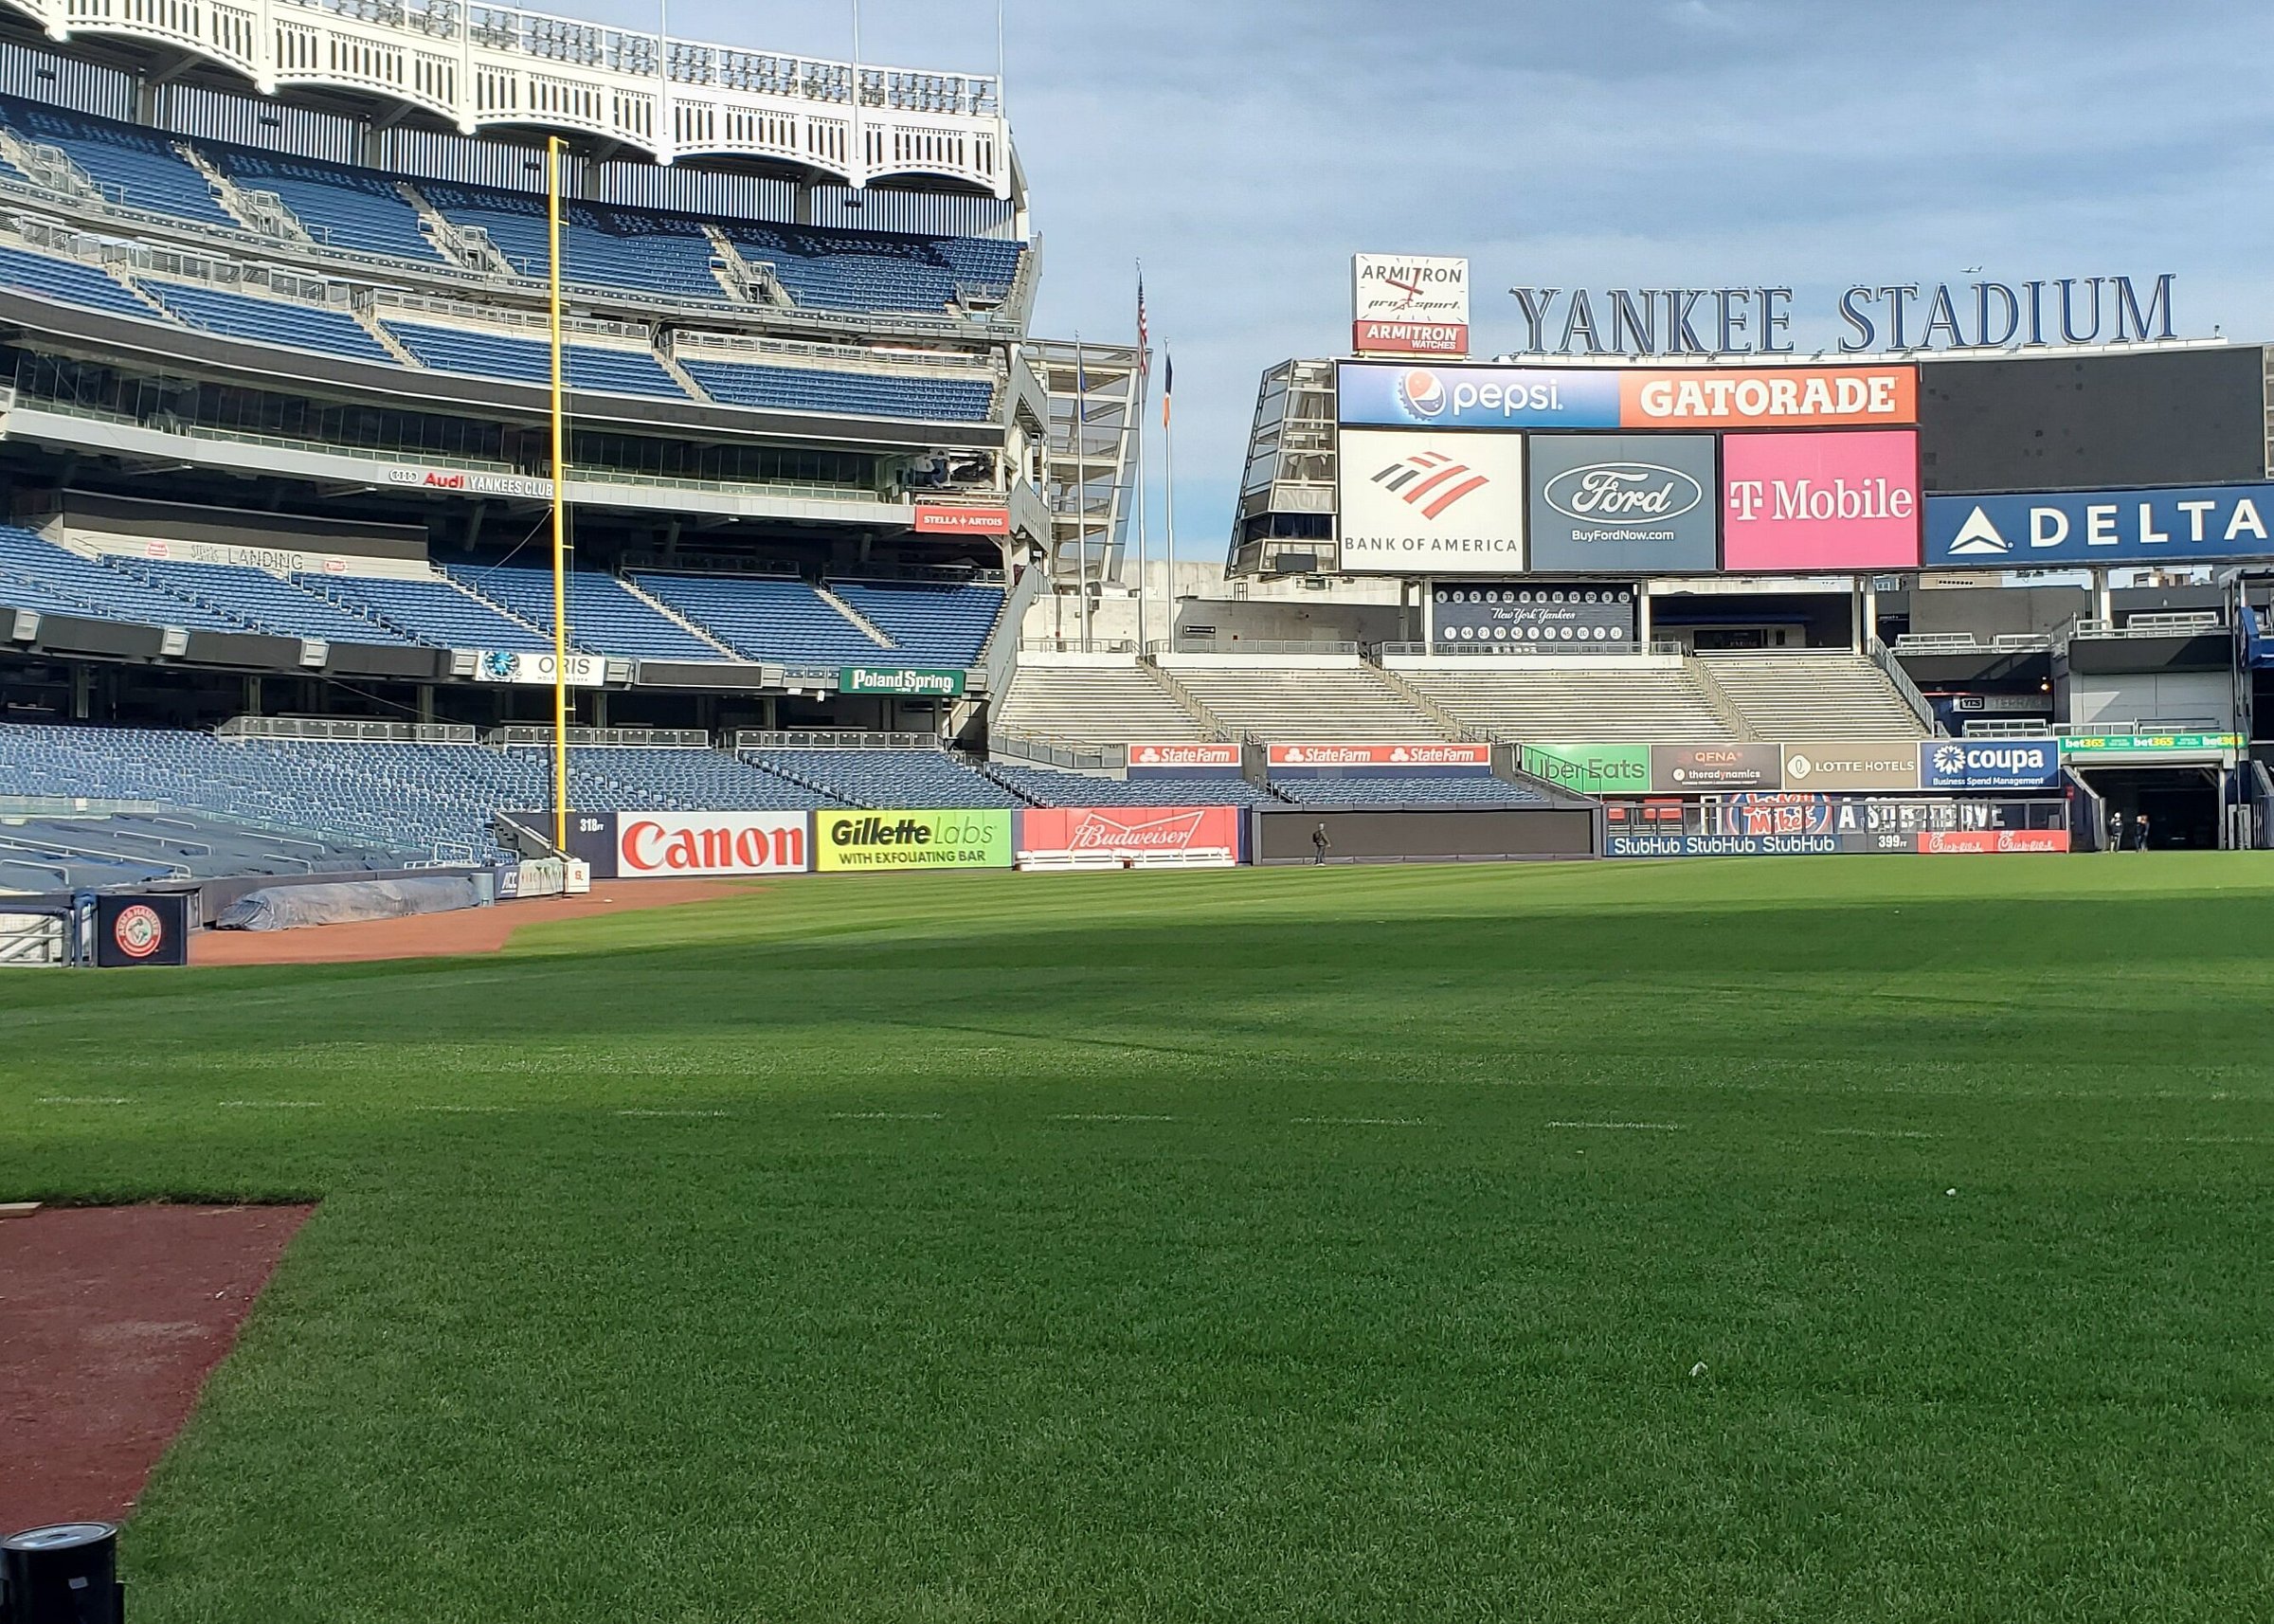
[1337,430,1524,575]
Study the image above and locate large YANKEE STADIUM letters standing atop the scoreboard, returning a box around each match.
[1507,273,2178,354]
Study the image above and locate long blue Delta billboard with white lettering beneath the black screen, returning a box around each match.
[1926,484,2274,568]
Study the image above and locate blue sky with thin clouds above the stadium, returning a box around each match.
[591,0,2274,552]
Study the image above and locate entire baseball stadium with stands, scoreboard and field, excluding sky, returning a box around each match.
[0,0,2274,1624]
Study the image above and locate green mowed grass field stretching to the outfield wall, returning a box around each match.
[0,856,2274,1624]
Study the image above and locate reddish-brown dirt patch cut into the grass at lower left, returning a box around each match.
[0,1205,314,1533]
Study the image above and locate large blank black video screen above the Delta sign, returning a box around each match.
[1920,343,2267,496]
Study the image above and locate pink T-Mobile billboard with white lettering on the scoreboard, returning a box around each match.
[1722,430,1920,571]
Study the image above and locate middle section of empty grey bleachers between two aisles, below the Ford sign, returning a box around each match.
[1399,655,1730,744]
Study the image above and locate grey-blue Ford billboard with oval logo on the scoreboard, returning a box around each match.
[1525,435,1719,575]
